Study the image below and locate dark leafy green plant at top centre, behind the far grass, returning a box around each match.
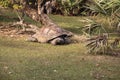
[57,0,83,15]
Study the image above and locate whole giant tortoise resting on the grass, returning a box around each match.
[28,25,73,45]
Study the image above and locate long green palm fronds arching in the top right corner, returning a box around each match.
[85,0,120,16]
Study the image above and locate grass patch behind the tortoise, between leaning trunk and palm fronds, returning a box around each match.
[50,15,84,34]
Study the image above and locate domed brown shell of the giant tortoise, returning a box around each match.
[32,24,73,43]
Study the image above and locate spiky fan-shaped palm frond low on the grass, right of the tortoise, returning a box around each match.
[86,35,108,54]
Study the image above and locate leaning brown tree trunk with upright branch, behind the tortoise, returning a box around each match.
[24,0,57,27]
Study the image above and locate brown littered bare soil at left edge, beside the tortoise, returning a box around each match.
[0,26,31,40]
